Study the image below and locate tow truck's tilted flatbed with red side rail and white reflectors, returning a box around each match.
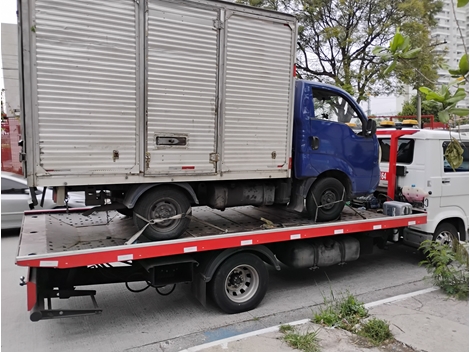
[16,206,426,268]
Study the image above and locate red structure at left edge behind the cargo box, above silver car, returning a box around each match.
[2,118,23,175]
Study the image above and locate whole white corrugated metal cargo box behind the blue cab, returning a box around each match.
[19,0,296,186]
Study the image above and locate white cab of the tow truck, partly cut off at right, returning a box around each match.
[378,129,469,247]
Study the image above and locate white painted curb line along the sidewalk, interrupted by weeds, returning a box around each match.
[180,287,439,352]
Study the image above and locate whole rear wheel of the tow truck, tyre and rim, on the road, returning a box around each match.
[209,253,269,314]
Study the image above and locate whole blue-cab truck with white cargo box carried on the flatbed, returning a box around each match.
[19,0,380,240]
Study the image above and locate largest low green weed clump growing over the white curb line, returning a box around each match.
[313,292,369,331]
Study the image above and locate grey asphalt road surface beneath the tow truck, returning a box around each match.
[1,232,431,352]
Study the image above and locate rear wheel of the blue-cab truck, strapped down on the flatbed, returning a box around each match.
[133,186,191,241]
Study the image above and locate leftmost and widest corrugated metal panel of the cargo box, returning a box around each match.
[33,0,137,174]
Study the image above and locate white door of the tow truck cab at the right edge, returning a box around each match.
[441,141,468,212]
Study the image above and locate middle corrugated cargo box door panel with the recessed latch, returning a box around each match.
[146,1,218,174]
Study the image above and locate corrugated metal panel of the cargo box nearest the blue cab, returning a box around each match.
[222,14,293,173]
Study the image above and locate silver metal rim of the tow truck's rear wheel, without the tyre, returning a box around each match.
[225,264,259,303]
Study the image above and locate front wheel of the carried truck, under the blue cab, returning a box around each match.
[307,177,345,221]
